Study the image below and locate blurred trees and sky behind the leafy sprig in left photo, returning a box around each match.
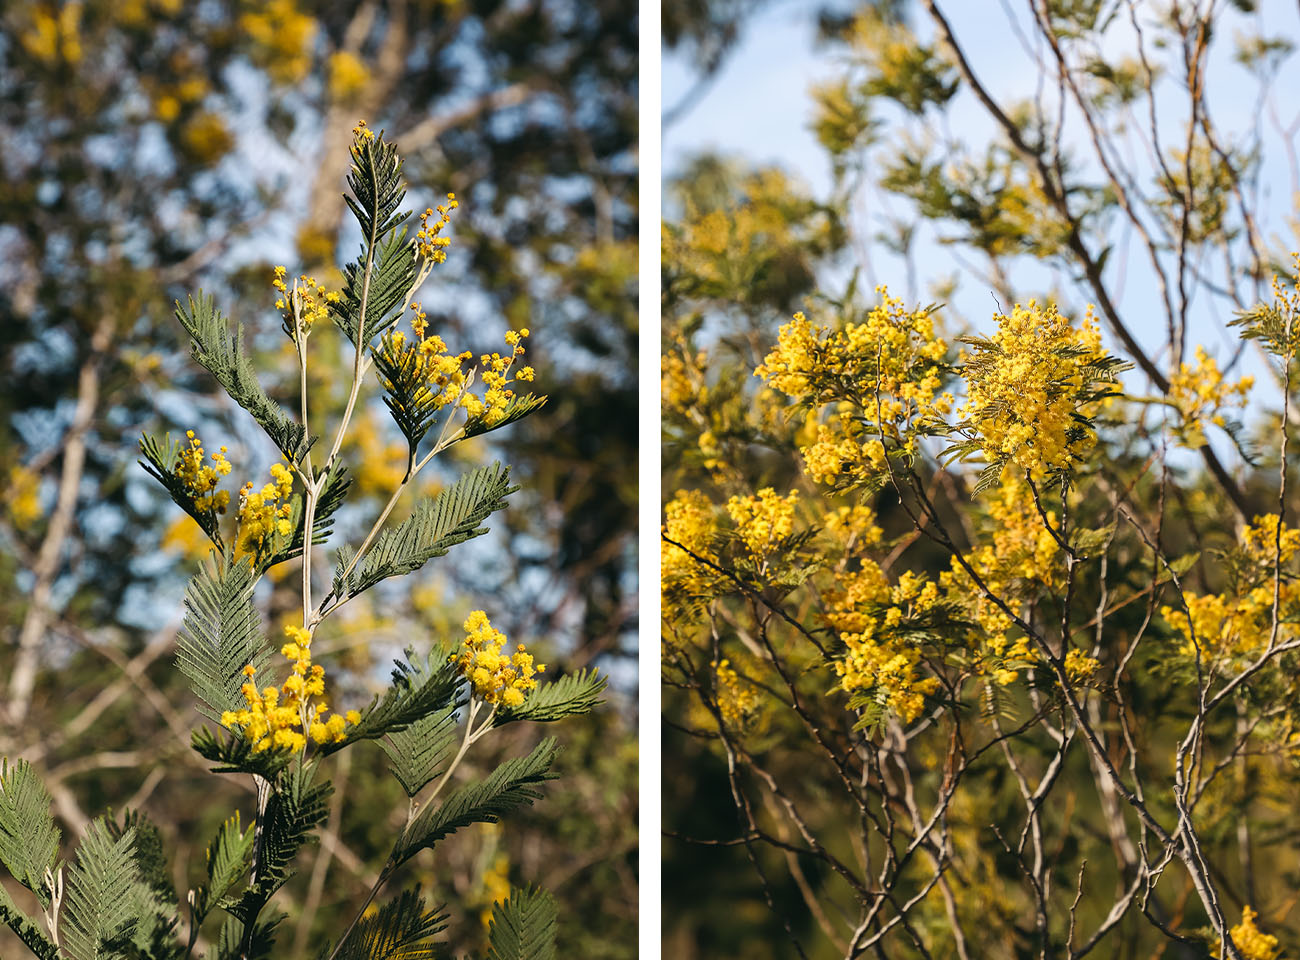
[0,0,637,957]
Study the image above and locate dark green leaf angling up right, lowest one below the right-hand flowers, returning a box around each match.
[393,736,559,865]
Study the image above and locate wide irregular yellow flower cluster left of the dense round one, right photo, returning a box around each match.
[754,286,953,484]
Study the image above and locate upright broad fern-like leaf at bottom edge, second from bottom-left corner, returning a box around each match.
[59,818,144,960]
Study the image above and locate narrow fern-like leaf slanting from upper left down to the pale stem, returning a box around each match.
[176,291,307,463]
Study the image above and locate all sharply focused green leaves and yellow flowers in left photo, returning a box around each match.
[0,124,603,960]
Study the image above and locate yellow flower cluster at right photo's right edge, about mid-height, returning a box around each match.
[1160,514,1300,663]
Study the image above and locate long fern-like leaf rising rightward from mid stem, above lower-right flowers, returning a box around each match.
[334,463,519,600]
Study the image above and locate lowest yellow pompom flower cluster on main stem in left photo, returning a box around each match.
[221,626,361,753]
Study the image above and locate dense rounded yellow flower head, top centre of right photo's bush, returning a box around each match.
[958,300,1106,480]
